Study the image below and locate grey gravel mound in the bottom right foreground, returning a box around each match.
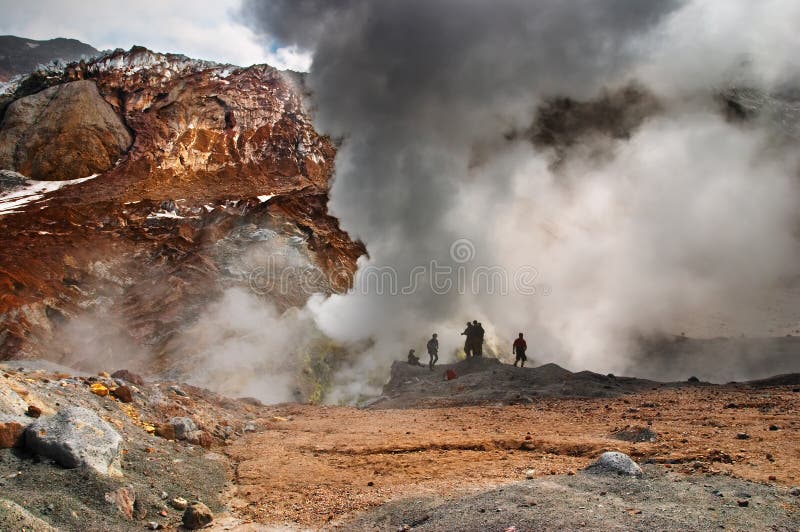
[340,465,800,532]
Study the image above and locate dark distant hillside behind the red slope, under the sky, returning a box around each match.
[0,35,97,81]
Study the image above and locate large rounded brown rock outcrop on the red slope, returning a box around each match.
[0,81,132,181]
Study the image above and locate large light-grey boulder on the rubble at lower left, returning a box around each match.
[25,407,122,475]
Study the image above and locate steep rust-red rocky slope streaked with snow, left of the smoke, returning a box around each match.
[0,48,364,382]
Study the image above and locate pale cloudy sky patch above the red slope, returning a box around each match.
[0,0,310,71]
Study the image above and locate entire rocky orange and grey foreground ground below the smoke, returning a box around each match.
[0,361,800,531]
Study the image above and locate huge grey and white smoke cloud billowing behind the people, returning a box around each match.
[242,0,798,394]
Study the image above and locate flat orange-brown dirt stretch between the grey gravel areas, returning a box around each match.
[227,386,800,527]
